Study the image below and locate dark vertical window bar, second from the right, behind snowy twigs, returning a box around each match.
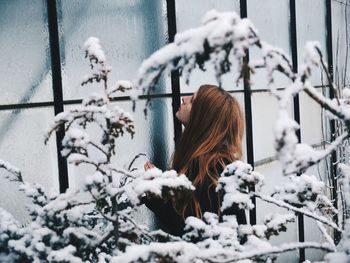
[289,0,305,262]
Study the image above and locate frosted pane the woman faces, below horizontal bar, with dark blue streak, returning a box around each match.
[67,99,174,188]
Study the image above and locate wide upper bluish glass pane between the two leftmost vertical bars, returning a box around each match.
[58,0,169,100]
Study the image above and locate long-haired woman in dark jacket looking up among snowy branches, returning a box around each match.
[144,85,246,235]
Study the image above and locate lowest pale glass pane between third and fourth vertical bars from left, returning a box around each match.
[255,161,299,263]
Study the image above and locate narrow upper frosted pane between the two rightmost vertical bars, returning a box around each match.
[296,0,328,85]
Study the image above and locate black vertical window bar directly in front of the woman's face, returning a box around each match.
[167,0,182,145]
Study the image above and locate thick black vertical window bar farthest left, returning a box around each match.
[47,0,68,193]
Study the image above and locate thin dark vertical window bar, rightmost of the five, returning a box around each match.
[325,0,341,244]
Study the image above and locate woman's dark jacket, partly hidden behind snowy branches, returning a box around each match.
[143,161,247,236]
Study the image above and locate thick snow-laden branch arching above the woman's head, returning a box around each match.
[136,10,259,98]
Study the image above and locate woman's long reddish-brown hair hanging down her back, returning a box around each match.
[173,85,244,218]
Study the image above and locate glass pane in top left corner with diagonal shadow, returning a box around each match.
[0,1,52,104]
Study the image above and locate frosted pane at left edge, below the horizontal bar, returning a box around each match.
[0,108,59,224]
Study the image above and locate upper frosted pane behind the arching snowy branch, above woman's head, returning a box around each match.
[176,0,243,93]
